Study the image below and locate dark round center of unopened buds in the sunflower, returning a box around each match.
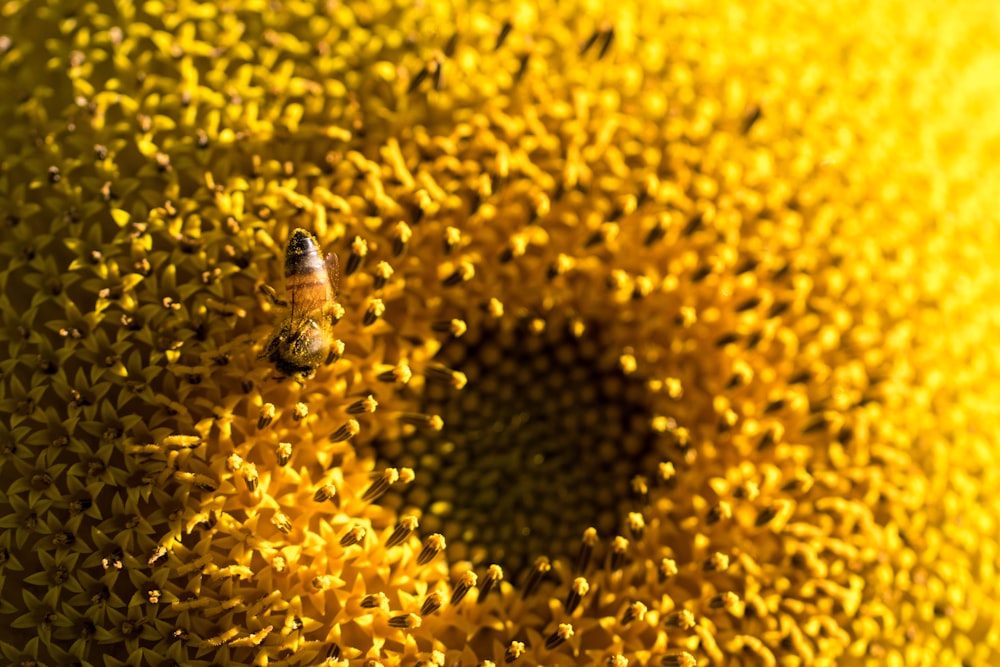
[388,320,655,576]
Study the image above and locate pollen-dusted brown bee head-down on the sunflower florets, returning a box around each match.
[259,229,340,382]
